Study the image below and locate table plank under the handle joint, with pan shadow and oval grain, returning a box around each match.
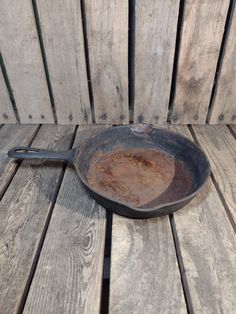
[24,127,106,314]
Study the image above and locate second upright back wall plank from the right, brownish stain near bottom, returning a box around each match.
[171,0,229,124]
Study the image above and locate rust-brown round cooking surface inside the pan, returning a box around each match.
[87,147,192,208]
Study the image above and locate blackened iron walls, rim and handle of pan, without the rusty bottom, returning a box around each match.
[8,124,210,218]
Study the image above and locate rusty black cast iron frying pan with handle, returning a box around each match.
[8,124,210,218]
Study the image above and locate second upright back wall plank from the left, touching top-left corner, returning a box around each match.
[0,0,54,123]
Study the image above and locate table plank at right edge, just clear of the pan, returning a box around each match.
[194,125,236,224]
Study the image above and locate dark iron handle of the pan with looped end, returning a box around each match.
[7,146,75,162]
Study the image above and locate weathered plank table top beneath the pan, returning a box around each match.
[0,125,236,314]
